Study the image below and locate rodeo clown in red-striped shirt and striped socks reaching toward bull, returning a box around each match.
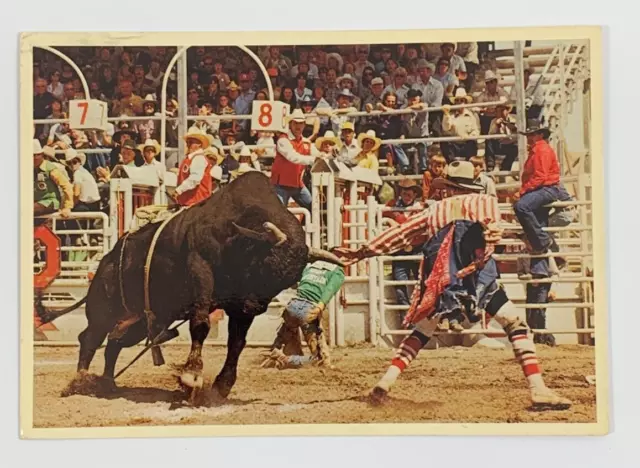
[333,161,571,408]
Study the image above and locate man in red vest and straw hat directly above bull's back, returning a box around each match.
[167,127,213,206]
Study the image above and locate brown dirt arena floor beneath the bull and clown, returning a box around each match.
[34,346,596,427]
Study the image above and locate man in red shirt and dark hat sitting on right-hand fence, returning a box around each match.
[513,120,571,256]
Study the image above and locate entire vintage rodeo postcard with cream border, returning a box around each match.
[20,28,608,437]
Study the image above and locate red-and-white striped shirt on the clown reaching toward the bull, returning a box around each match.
[363,194,500,256]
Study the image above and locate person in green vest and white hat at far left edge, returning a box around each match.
[33,139,73,218]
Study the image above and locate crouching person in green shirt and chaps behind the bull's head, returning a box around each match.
[260,260,345,369]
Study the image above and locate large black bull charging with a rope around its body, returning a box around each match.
[38,172,340,397]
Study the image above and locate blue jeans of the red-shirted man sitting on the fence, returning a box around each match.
[513,185,568,252]
